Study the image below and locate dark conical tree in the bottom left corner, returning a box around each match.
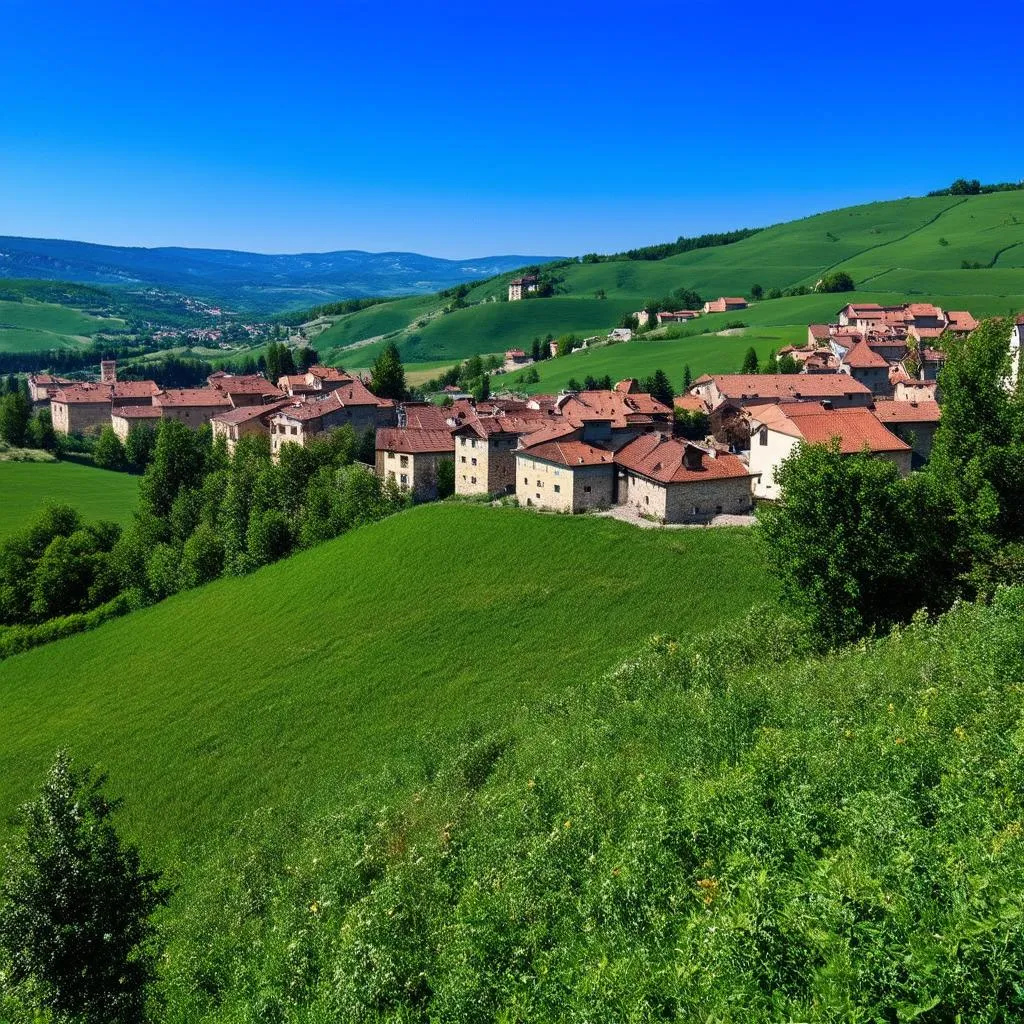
[0,752,169,1024]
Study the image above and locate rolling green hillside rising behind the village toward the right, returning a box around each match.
[316,191,1024,372]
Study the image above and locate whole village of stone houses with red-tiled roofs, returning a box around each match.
[29,299,1024,524]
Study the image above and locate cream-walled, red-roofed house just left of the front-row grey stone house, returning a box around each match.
[515,439,615,512]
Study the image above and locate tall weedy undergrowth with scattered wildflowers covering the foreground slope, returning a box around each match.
[151,591,1024,1024]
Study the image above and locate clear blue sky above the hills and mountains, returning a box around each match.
[0,0,1024,257]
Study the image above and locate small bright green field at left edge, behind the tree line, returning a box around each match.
[0,462,138,538]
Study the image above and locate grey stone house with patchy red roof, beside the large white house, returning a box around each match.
[614,433,753,522]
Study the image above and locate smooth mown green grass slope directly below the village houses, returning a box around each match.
[0,504,772,863]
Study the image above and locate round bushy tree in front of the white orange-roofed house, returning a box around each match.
[759,440,945,646]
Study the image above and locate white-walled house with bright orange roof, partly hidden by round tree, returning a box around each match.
[745,401,912,500]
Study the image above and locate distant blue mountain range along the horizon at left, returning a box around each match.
[0,236,556,310]
